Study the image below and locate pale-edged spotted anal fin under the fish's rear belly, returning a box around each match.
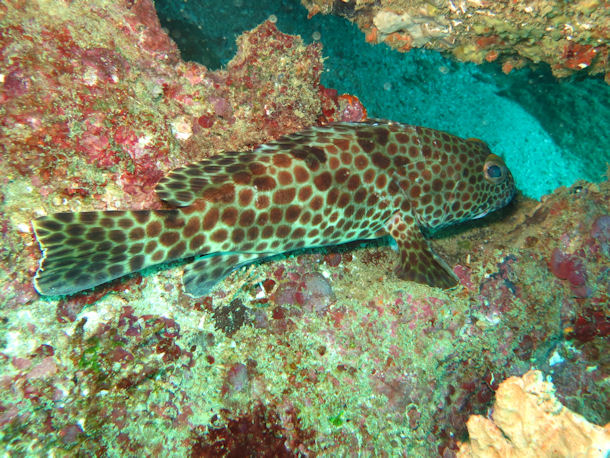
[182,253,271,297]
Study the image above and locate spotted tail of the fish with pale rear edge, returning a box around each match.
[33,210,186,295]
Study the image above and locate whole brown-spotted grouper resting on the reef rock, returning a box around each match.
[32,119,515,297]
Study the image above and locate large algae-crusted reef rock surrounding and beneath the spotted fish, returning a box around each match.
[0,0,610,456]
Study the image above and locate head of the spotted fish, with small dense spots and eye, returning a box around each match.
[415,135,516,230]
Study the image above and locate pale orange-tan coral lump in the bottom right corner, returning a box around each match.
[458,371,610,458]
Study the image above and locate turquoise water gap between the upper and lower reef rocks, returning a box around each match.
[155,0,610,198]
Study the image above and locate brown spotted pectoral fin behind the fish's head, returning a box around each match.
[386,213,459,288]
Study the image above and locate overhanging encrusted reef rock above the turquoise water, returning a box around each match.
[302,0,610,83]
